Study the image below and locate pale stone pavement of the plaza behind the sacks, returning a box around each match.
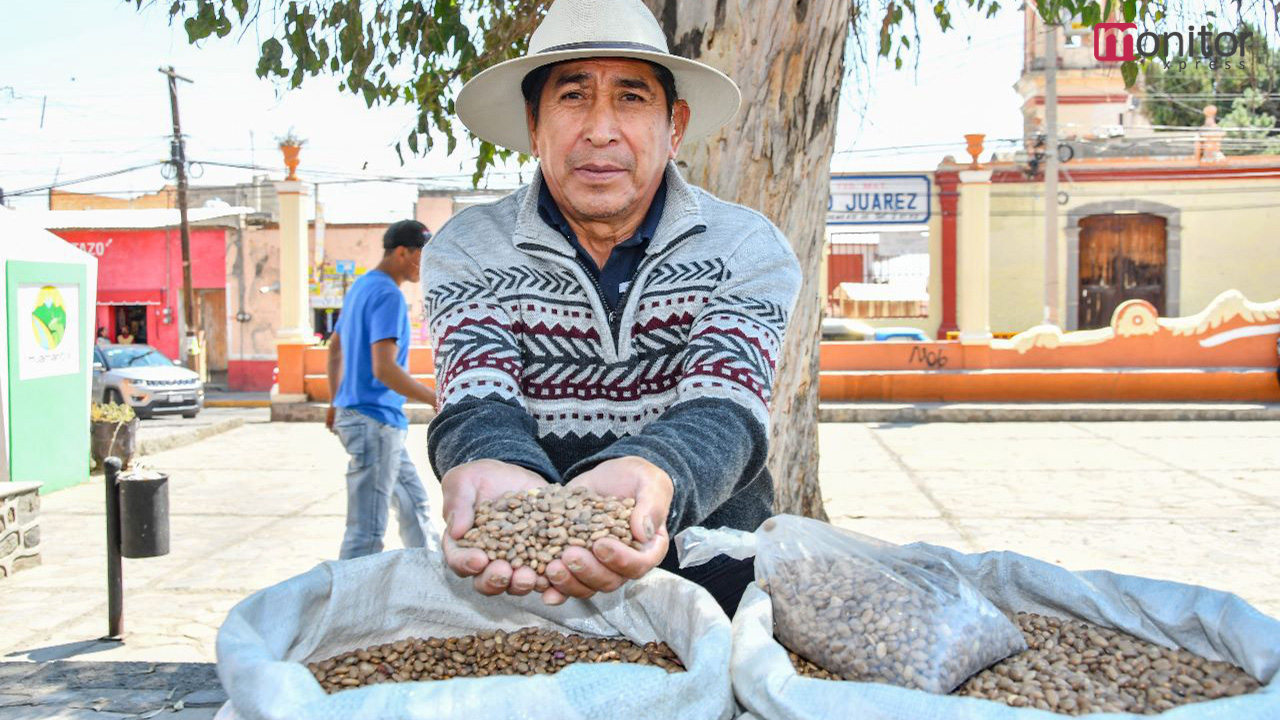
[0,421,1280,720]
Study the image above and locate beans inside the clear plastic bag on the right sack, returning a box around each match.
[758,555,1027,693]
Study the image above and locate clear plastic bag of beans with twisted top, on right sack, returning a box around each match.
[676,515,1027,693]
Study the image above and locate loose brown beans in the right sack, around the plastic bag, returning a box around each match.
[790,612,1260,715]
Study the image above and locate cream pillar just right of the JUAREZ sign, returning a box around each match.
[956,169,991,345]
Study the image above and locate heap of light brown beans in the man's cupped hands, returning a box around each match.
[457,486,644,575]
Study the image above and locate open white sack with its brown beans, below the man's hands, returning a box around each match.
[218,550,735,720]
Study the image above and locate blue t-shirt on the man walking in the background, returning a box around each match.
[333,270,408,429]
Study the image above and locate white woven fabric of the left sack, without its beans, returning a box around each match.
[218,550,733,720]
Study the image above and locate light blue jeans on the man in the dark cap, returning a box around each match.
[333,407,439,560]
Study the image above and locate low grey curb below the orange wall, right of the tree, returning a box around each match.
[818,402,1280,423]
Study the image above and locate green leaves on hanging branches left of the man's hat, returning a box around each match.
[148,0,550,182]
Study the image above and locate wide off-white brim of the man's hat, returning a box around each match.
[454,47,742,154]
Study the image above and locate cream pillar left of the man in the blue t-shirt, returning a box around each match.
[275,181,315,345]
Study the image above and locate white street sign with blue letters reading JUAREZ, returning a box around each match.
[827,174,931,225]
